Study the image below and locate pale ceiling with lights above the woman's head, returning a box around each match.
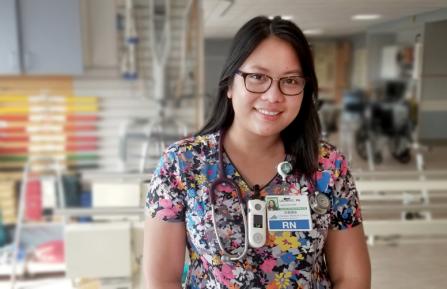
[203,0,447,38]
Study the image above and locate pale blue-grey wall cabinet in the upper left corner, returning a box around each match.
[0,0,83,75]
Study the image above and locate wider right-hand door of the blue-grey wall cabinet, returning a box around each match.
[18,0,83,75]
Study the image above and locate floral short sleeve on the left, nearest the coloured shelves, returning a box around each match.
[145,150,186,222]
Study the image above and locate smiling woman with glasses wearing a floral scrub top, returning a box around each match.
[144,17,370,289]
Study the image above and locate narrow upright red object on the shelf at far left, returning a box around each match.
[25,179,42,221]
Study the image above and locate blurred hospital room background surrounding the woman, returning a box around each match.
[0,0,447,289]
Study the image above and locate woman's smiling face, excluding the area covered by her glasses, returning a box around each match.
[227,36,304,137]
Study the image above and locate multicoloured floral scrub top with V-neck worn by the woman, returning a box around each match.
[146,132,362,289]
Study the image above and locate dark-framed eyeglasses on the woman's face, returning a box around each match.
[236,70,306,95]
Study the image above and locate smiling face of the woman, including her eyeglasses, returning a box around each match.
[227,36,304,139]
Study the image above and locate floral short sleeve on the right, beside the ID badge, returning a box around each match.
[331,151,362,230]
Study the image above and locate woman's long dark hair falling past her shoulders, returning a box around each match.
[198,16,321,177]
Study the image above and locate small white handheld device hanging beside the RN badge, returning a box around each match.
[248,200,267,248]
